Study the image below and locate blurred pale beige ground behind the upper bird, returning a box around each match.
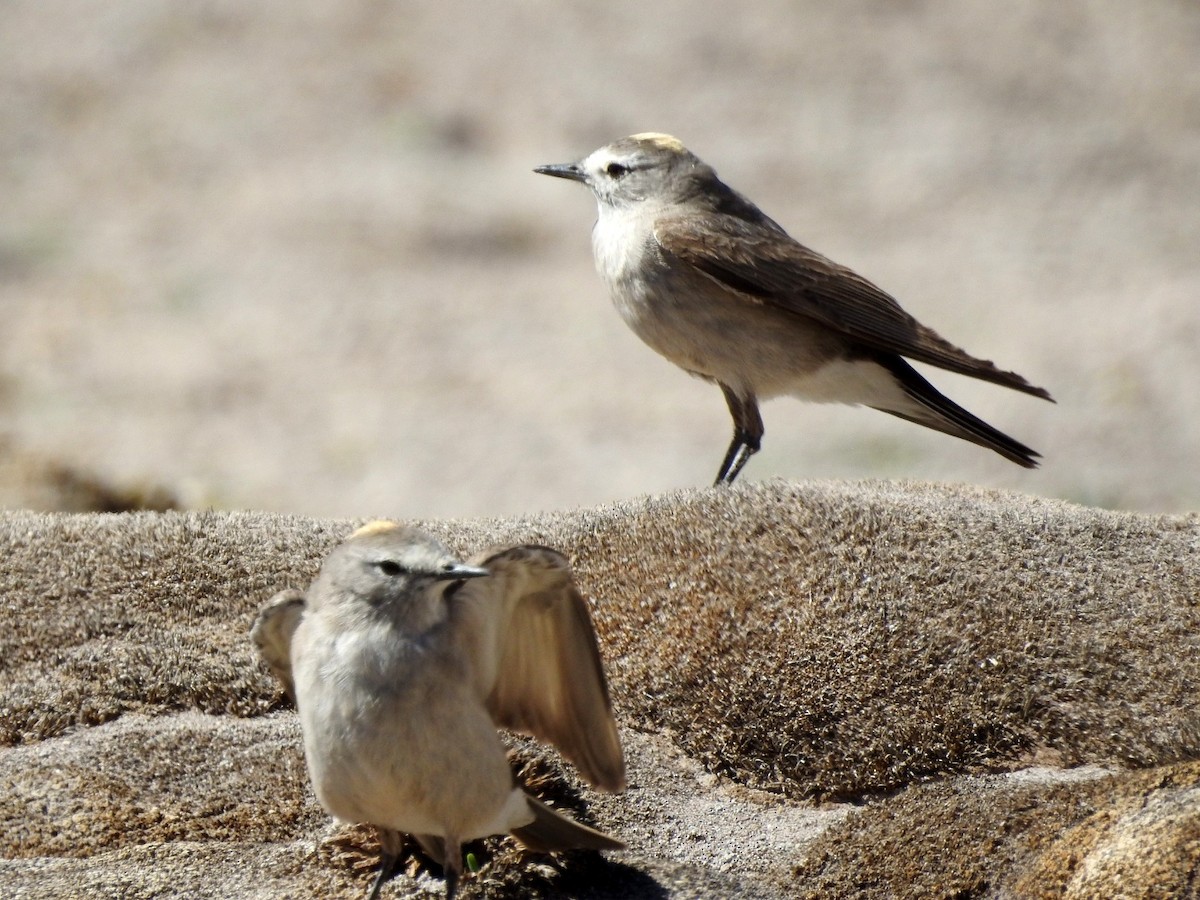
[0,0,1200,517]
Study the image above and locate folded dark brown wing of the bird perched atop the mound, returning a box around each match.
[654,213,1050,400]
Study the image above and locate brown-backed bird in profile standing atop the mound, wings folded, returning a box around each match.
[534,133,1051,485]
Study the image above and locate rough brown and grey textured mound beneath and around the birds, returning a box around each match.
[0,482,1200,898]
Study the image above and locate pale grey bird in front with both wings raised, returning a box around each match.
[251,522,625,900]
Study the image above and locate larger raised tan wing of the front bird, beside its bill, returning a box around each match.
[451,546,625,791]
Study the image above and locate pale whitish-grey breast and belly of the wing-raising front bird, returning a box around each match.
[296,631,512,836]
